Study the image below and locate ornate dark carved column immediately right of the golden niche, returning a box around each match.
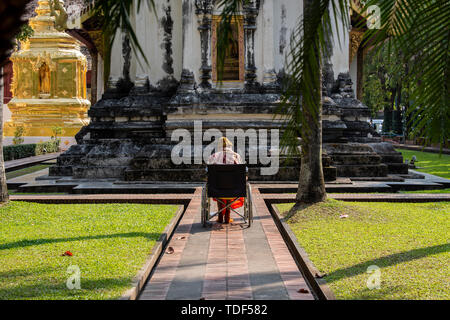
[243,1,258,87]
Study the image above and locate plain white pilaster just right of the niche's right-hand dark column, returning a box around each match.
[262,0,277,87]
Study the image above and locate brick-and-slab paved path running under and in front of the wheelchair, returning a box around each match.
[139,188,314,300]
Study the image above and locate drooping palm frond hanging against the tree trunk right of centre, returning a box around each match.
[277,0,349,155]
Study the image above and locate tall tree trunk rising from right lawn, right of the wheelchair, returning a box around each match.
[296,0,327,204]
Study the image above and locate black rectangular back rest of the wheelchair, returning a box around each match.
[207,164,247,198]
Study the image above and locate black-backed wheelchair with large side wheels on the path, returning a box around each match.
[201,164,253,227]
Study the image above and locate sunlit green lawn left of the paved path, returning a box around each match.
[0,202,178,300]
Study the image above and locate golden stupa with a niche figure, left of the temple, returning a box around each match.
[4,0,91,138]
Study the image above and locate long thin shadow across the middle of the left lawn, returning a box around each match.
[0,232,161,250]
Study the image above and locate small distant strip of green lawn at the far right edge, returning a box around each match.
[396,149,450,179]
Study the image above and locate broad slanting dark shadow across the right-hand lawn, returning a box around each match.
[326,243,450,283]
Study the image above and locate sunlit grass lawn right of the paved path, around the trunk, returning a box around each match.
[277,200,450,299]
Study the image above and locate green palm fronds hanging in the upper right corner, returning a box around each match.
[365,0,450,148]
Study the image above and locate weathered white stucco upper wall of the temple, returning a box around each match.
[110,0,356,87]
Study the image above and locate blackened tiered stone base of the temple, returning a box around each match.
[50,72,407,182]
